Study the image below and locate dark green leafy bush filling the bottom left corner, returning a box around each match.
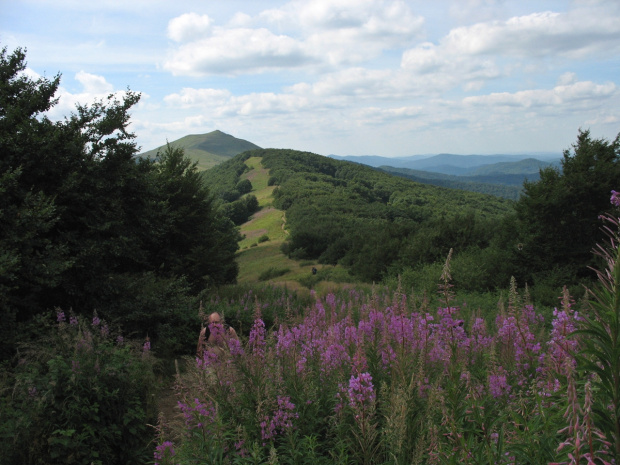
[0,310,157,465]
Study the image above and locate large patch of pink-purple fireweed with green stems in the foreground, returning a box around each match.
[158,263,610,464]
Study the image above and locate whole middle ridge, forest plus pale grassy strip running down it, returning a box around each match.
[204,149,513,288]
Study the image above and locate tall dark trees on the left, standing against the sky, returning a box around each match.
[0,48,239,354]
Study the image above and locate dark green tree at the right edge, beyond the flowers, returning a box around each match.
[514,130,620,285]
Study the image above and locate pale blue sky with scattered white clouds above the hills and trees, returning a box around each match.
[0,0,620,156]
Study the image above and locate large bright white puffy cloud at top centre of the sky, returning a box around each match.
[164,0,424,76]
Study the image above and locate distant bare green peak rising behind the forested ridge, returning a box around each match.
[140,130,260,170]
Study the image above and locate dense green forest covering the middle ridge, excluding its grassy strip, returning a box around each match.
[204,149,512,286]
